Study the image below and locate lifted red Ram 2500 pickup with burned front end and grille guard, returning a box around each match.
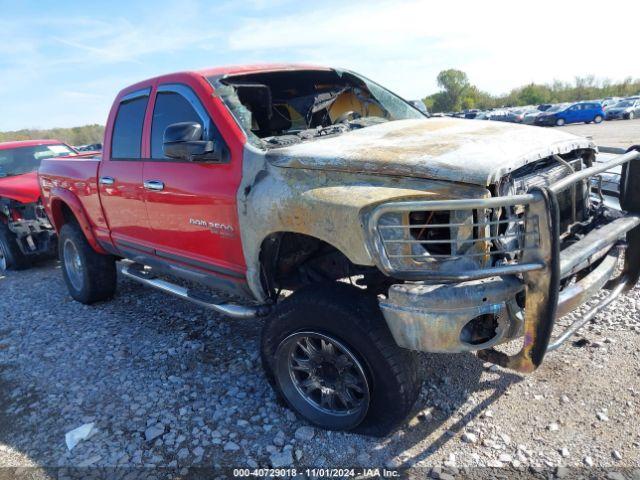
[39,65,640,434]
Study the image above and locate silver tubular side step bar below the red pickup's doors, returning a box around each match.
[120,263,269,319]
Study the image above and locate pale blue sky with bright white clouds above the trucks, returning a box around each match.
[0,0,640,131]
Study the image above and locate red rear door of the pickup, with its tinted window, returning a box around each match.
[98,88,152,253]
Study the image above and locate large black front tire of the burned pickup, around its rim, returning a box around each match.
[261,283,422,436]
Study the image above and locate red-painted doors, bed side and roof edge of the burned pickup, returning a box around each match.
[40,65,296,282]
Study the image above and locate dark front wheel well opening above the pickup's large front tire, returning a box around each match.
[260,232,389,299]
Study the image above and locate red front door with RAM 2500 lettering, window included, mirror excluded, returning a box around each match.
[143,83,245,278]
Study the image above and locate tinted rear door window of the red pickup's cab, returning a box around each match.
[111,95,149,159]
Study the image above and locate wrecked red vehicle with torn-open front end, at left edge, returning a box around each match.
[0,140,84,271]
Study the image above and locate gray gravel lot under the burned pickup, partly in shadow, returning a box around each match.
[0,122,640,478]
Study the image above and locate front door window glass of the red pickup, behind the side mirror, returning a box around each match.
[151,91,204,158]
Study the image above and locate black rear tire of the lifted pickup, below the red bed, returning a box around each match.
[58,223,117,305]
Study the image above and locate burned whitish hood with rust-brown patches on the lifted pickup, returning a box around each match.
[267,118,595,186]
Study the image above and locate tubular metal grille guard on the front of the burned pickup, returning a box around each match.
[367,150,640,373]
